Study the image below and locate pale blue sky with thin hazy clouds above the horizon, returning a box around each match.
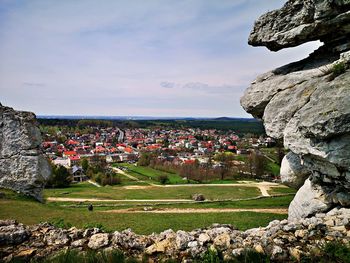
[0,0,320,117]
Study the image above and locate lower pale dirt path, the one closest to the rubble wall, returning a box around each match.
[99,208,288,214]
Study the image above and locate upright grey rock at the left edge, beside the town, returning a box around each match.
[0,104,51,201]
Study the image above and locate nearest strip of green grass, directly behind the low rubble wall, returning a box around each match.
[0,200,286,234]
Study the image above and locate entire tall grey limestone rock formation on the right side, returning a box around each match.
[241,0,350,219]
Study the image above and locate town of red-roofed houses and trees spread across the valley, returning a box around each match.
[42,122,283,186]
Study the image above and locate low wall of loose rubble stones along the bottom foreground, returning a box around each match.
[0,208,350,262]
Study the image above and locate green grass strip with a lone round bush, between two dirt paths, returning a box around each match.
[44,183,261,200]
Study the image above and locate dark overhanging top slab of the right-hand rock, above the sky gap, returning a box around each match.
[249,0,350,51]
